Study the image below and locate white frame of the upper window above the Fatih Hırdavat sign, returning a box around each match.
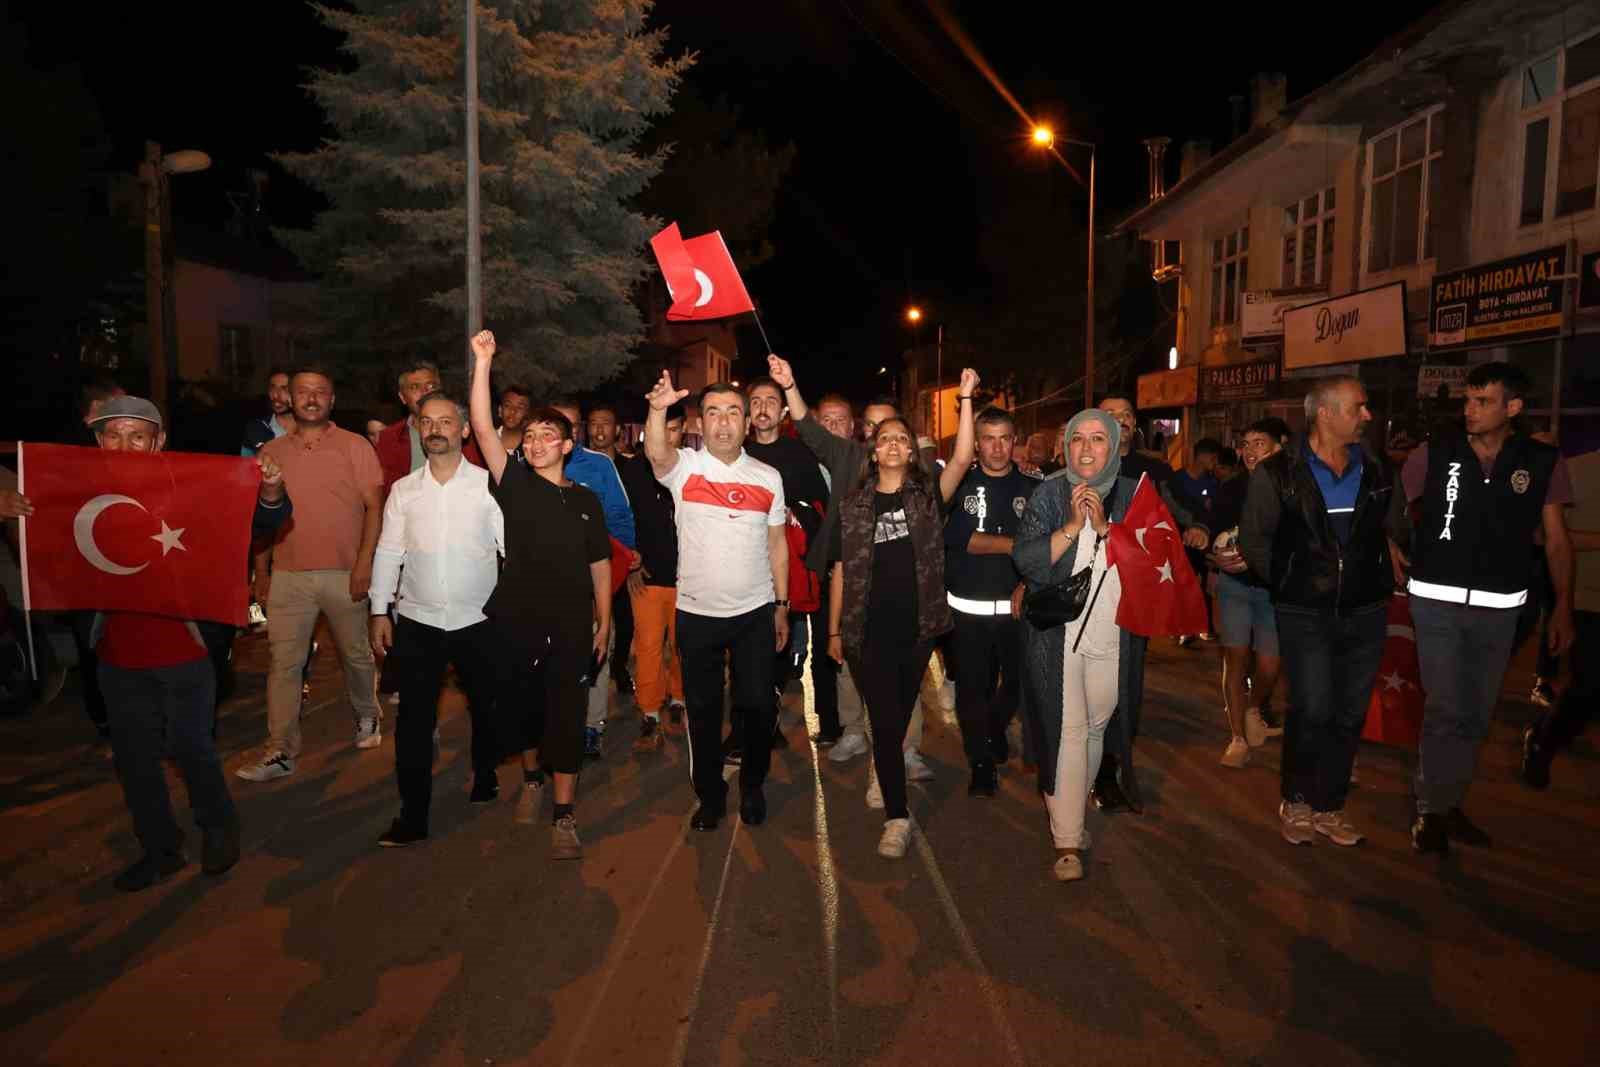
[1510,29,1600,230]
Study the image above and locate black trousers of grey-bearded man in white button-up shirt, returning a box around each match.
[386,616,502,833]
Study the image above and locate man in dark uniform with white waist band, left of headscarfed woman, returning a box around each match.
[944,408,1038,797]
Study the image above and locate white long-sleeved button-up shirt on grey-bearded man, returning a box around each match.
[371,459,506,630]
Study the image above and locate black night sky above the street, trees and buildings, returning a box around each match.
[6,0,1432,398]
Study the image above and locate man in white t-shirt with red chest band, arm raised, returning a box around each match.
[645,371,789,830]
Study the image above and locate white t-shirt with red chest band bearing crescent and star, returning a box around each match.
[661,448,787,619]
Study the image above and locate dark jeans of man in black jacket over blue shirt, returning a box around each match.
[1277,605,1389,811]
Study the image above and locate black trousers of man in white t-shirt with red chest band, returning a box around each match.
[677,605,778,809]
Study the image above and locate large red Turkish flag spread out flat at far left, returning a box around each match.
[18,445,261,625]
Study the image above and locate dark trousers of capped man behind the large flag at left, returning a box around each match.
[99,657,238,853]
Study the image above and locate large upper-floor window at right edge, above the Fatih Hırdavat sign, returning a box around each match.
[1517,34,1600,226]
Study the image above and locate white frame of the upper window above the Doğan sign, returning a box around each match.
[1362,102,1445,277]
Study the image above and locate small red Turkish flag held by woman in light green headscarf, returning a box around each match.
[1106,475,1206,637]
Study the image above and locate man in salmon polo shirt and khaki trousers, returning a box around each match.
[237,366,384,782]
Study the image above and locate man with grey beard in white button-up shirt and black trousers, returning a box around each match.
[368,392,506,848]
